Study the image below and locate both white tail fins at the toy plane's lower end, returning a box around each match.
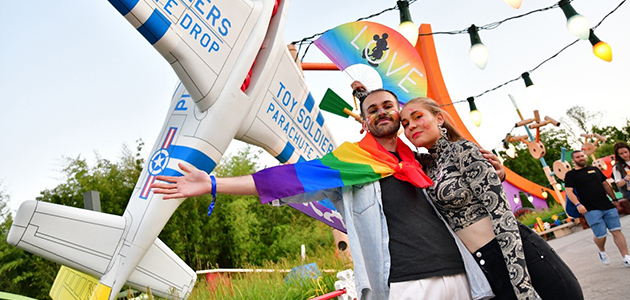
[7,200,197,297]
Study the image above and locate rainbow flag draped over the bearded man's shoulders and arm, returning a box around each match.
[252,133,433,203]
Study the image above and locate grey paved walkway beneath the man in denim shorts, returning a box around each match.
[549,215,630,300]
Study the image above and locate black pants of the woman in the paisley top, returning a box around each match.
[473,222,584,300]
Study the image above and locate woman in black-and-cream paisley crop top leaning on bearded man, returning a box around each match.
[401,98,583,299]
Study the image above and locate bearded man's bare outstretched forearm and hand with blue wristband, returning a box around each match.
[151,163,258,200]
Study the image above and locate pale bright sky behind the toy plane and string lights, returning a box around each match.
[0,0,630,210]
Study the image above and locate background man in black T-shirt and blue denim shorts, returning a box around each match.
[564,150,630,267]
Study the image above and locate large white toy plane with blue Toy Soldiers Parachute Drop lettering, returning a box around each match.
[7,0,345,300]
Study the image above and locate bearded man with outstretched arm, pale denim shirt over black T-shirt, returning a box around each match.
[152,90,504,300]
